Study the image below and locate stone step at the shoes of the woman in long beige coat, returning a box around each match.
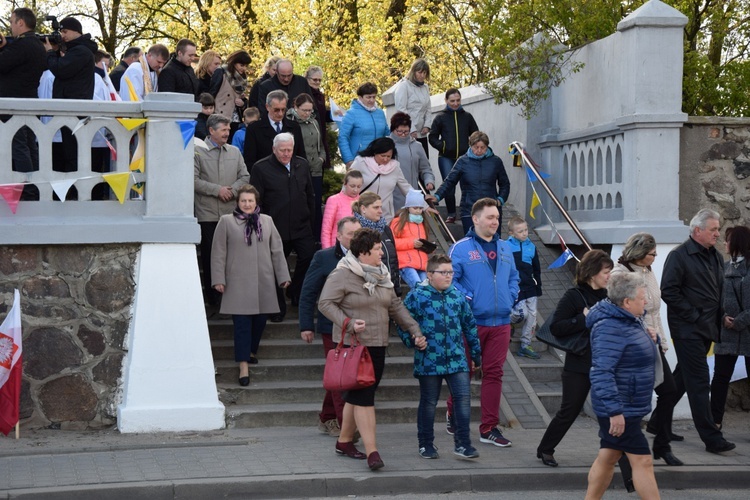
[214,353,414,387]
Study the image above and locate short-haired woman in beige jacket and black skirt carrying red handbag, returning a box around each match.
[318,228,426,470]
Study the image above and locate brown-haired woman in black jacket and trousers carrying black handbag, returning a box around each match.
[536,250,614,467]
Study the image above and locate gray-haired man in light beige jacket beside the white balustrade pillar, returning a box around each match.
[193,114,250,305]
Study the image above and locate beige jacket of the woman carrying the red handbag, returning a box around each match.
[318,268,422,347]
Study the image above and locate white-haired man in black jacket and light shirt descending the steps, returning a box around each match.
[250,132,315,322]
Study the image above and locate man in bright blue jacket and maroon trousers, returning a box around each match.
[447,198,519,447]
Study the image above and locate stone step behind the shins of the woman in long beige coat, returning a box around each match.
[211,331,414,361]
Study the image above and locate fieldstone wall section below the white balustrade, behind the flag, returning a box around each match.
[0,244,140,429]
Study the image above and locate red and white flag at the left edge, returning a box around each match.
[0,290,21,436]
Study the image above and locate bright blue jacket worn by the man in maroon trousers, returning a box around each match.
[448,228,519,326]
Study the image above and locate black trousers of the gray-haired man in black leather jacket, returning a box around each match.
[674,339,724,446]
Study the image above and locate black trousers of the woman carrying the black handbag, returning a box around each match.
[537,370,591,455]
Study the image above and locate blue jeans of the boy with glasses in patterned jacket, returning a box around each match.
[417,372,471,447]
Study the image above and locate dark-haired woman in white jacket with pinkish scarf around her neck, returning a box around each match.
[351,137,412,223]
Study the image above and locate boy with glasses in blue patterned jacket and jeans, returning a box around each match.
[398,255,481,458]
